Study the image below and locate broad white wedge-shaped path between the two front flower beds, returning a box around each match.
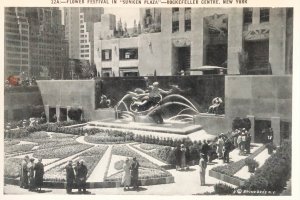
[87,145,113,182]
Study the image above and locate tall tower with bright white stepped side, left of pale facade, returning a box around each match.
[64,8,104,64]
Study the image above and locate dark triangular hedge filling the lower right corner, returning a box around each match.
[242,141,291,193]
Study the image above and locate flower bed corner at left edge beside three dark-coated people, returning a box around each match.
[4,158,23,178]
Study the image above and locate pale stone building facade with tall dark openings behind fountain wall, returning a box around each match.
[94,8,293,76]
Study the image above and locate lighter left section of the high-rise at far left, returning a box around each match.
[4,8,29,78]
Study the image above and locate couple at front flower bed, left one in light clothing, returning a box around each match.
[122,157,140,191]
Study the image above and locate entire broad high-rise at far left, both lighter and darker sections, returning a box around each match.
[5,8,68,78]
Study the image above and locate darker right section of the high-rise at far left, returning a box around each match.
[26,8,68,79]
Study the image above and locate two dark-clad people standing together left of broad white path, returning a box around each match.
[65,160,88,194]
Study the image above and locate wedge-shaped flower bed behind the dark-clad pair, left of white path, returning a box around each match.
[44,145,108,182]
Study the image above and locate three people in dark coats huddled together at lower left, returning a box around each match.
[20,155,44,191]
